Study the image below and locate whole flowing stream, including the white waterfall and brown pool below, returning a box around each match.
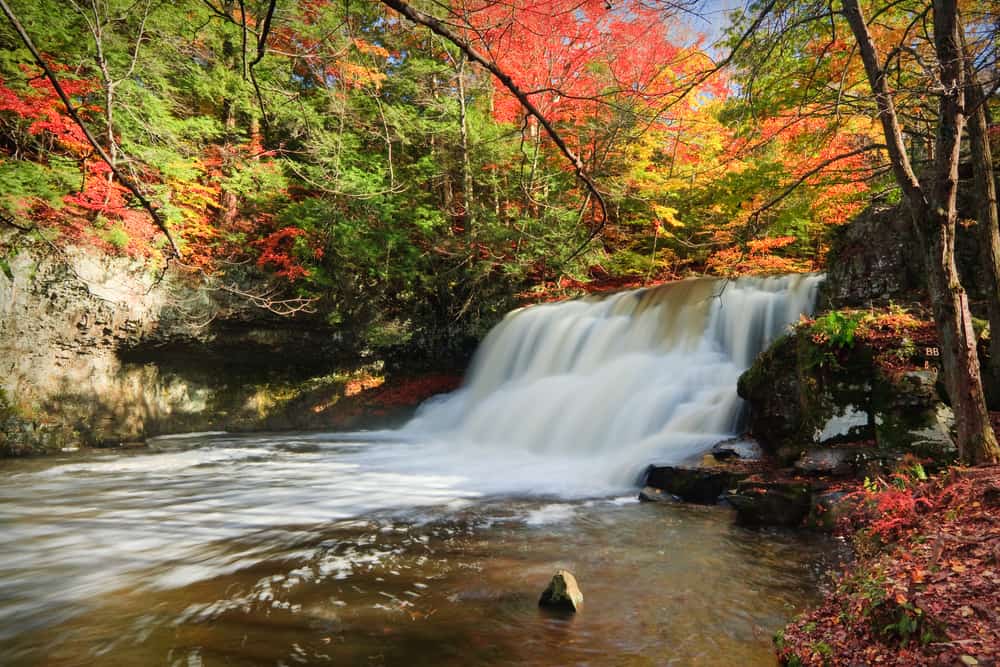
[0,276,832,666]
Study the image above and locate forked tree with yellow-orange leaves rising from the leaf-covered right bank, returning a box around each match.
[734,0,1000,463]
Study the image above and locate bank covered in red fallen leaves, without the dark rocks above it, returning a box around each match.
[775,464,1000,666]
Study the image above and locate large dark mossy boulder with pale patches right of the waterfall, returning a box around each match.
[737,330,956,474]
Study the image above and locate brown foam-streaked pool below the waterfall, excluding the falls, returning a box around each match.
[0,435,836,667]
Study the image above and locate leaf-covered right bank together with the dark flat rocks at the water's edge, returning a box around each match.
[639,428,1000,667]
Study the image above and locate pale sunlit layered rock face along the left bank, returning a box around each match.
[0,239,341,455]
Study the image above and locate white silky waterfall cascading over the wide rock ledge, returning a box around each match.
[405,274,823,485]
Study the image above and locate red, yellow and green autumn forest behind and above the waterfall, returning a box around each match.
[0,1,888,334]
